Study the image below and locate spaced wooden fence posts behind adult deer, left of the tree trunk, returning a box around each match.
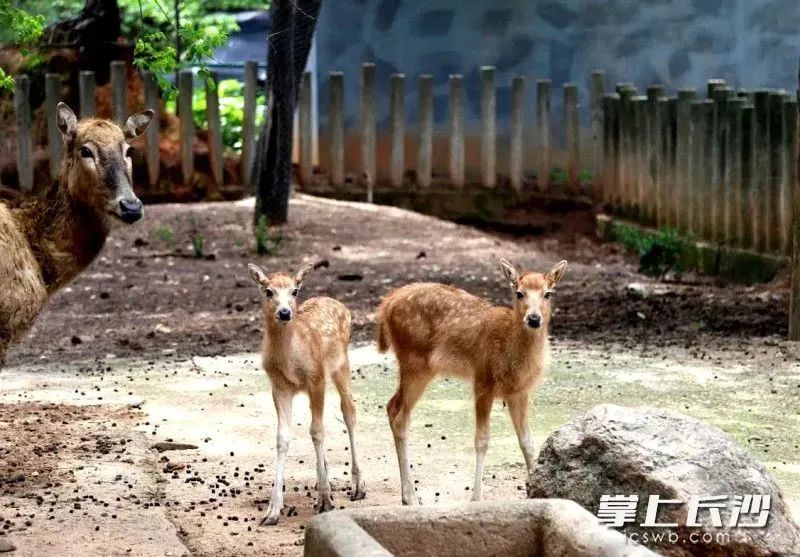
[4,61,258,191]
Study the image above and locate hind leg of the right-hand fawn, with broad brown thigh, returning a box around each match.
[386,362,431,505]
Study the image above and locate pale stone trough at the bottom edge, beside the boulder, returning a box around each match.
[305,499,656,557]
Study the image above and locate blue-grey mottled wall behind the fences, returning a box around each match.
[317,0,800,143]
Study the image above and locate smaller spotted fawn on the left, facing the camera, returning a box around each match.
[248,263,366,525]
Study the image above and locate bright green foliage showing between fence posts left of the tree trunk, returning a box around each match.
[165,79,265,153]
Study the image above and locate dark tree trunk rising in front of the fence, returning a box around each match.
[252,0,322,225]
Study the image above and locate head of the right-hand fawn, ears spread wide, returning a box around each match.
[500,259,567,329]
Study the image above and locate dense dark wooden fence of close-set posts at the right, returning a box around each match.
[601,80,797,255]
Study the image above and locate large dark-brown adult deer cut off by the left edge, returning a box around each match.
[0,103,153,368]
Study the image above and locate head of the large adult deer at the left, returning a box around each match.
[58,103,154,224]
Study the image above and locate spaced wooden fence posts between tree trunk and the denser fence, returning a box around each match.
[298,63,592,201]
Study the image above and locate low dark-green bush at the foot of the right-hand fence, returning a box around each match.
[615,224,691,276]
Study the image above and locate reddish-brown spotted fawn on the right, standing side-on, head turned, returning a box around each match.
[377,259,567,505]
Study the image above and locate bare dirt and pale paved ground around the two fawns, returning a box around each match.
[0,196,800,555]
